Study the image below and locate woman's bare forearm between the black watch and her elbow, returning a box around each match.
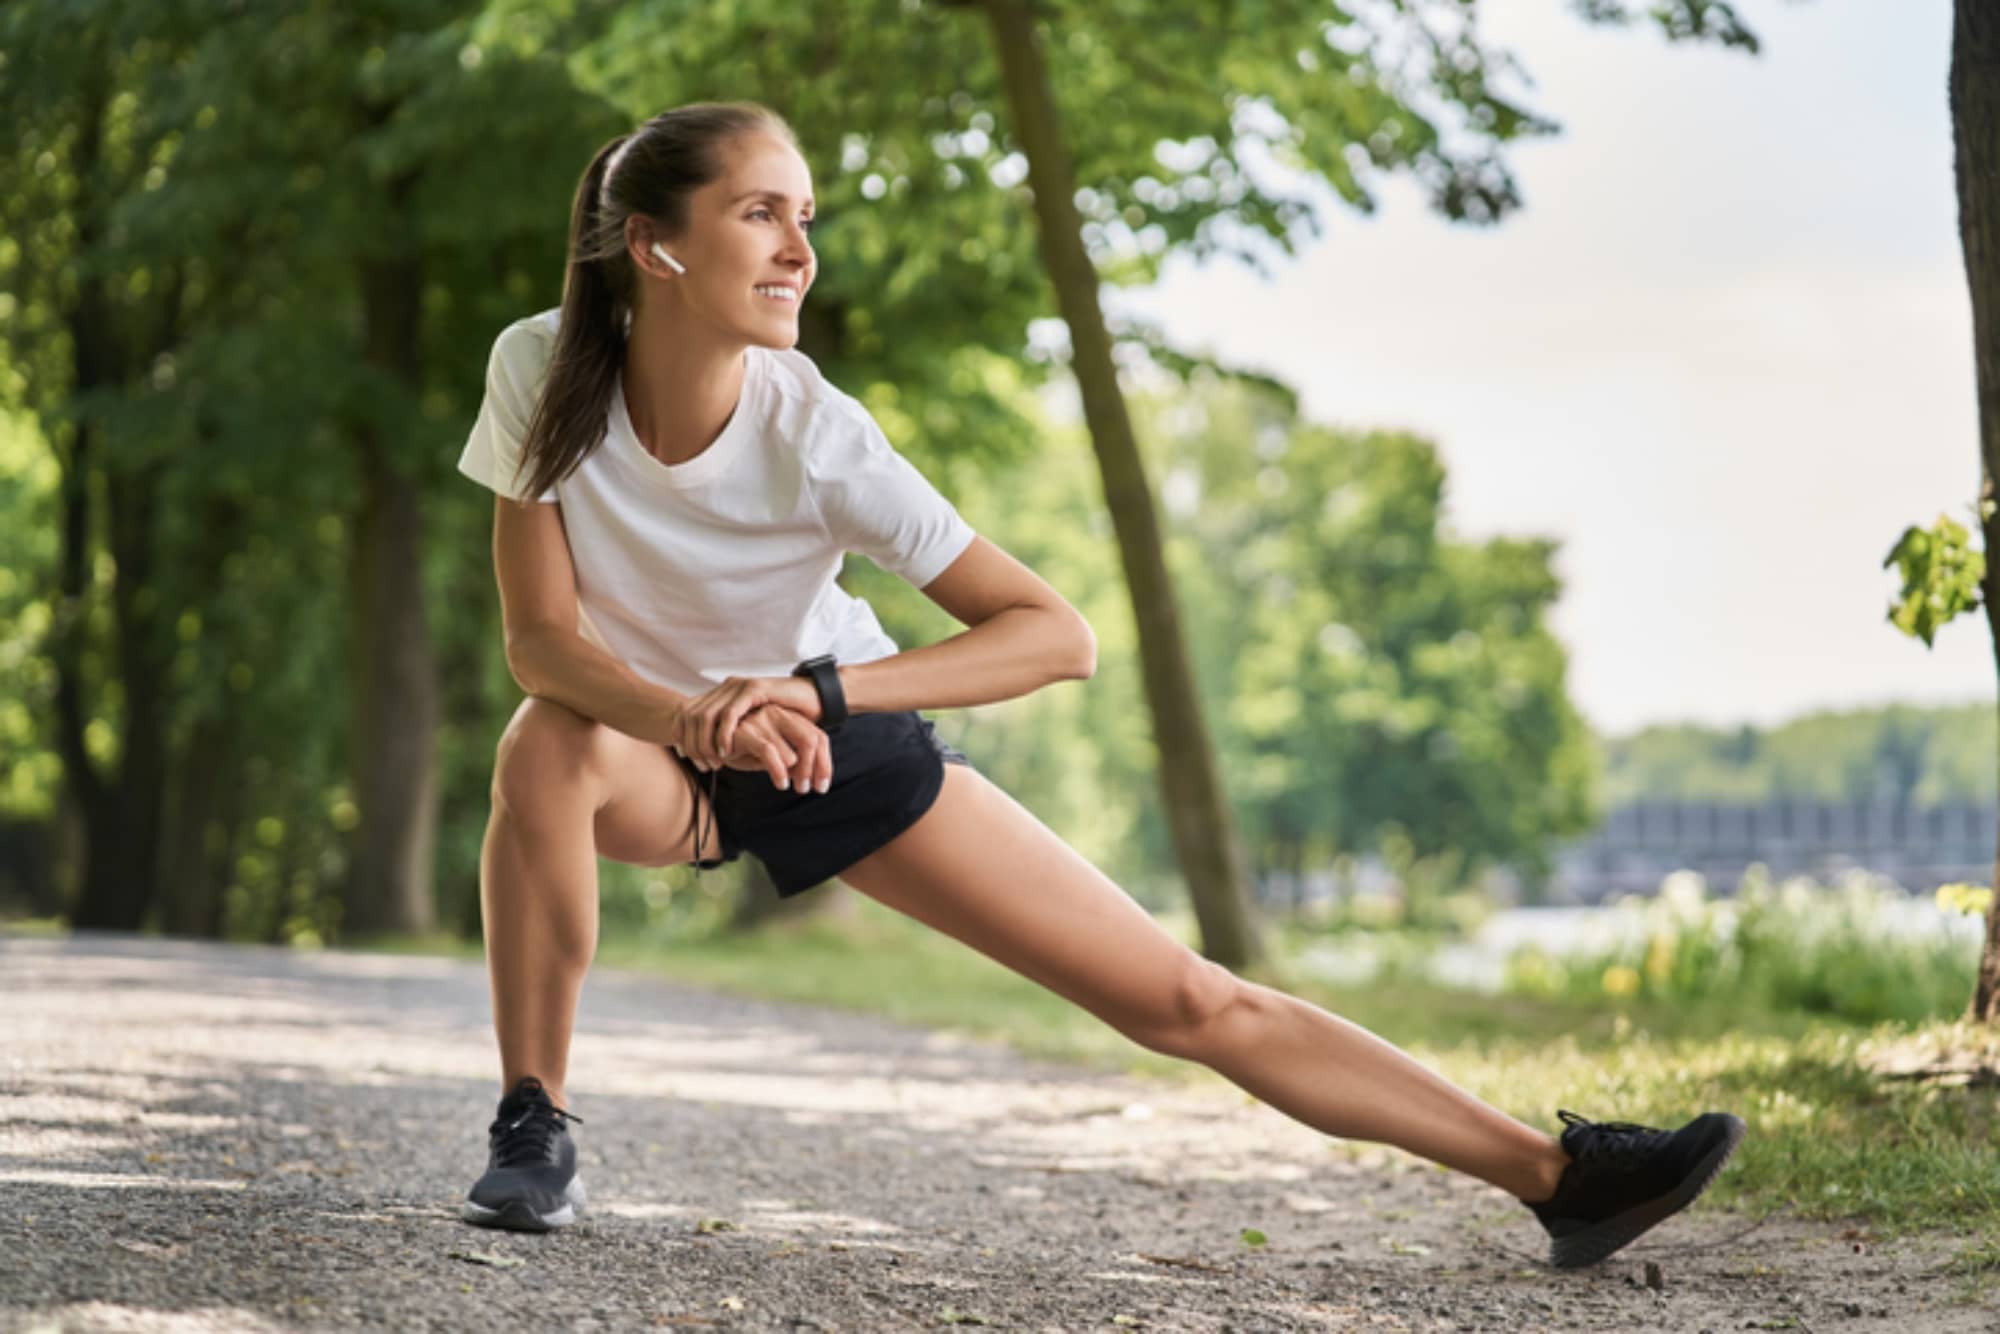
[840,606,1098,714]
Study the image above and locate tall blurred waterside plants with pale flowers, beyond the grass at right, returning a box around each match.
[1506,868,1978,1024]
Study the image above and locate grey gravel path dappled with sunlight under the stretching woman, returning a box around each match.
[0,936,2000,1334]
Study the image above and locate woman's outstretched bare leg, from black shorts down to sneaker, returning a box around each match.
[840,764,1568,1200]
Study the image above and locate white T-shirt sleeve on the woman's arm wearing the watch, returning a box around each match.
[810,400,976,588]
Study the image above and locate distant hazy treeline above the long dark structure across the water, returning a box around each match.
[1602,704,2000,804]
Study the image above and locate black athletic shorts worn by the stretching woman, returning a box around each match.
[668,710,972,898]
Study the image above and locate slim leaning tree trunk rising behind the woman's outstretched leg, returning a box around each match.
[986,0,1262,968]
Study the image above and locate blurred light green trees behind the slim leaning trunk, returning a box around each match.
[848,374,1592,904]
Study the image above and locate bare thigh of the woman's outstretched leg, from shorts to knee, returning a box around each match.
[840,764,1240,1042]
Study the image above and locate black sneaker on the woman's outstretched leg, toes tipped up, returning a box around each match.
[1528,1112,1744,1270]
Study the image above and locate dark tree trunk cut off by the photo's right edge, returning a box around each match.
[1950,0,2000,1024]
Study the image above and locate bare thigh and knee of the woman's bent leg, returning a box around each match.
[494,696,714,866]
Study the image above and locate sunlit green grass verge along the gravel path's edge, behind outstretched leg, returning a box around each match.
[600,900,2000,1256]
